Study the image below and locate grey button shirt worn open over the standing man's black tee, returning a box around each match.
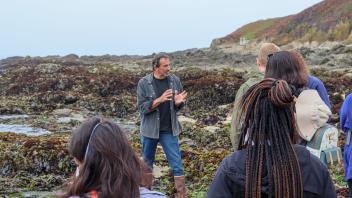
[137,73,184,139]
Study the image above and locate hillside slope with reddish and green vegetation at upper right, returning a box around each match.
[212,0,352,46]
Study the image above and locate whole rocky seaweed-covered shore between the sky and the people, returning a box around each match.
[0,44,352,197]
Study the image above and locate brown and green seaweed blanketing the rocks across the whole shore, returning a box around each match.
[0,58,352,197]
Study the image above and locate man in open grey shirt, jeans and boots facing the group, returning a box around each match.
[137,54,187,198]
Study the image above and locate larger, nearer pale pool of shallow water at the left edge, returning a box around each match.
[0,124,51,136]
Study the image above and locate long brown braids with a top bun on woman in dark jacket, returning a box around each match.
[238,78,303,198]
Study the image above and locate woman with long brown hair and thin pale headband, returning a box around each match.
[58,118,165,198]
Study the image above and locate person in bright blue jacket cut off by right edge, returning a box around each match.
[340,93,352,197]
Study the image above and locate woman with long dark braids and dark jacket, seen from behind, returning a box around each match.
[207,78,336,198]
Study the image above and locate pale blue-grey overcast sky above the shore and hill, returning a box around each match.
[0,0,321,59]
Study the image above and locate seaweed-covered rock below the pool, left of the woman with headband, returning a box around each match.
[0,133,74,193]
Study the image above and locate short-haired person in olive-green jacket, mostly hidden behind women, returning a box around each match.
[230,43,280,151]
